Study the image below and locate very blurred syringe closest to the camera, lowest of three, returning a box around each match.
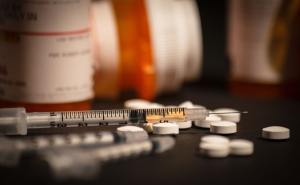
[43,136,175,180]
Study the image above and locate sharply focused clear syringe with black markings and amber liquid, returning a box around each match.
[0,107,238,135]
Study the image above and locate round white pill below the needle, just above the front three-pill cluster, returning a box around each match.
[210,121,236,134]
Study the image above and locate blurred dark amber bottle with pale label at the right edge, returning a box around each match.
[227,0,300,98]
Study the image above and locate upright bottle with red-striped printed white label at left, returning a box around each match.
[0,0,93,112]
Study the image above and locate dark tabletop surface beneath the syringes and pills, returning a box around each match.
[0,84,300,184]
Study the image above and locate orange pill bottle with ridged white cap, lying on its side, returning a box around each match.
[92,0,202,100]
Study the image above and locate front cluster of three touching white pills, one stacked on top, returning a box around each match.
[199,135,254,158]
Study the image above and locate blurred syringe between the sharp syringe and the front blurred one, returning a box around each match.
[0,131,149,167]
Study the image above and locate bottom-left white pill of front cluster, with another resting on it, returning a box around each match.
[199,142,229,158]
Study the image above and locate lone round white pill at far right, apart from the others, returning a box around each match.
[262,126,290,140]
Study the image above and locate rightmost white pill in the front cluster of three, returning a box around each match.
[229,139,253,155]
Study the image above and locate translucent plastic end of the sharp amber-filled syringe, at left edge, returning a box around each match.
[0,107,27,135]
